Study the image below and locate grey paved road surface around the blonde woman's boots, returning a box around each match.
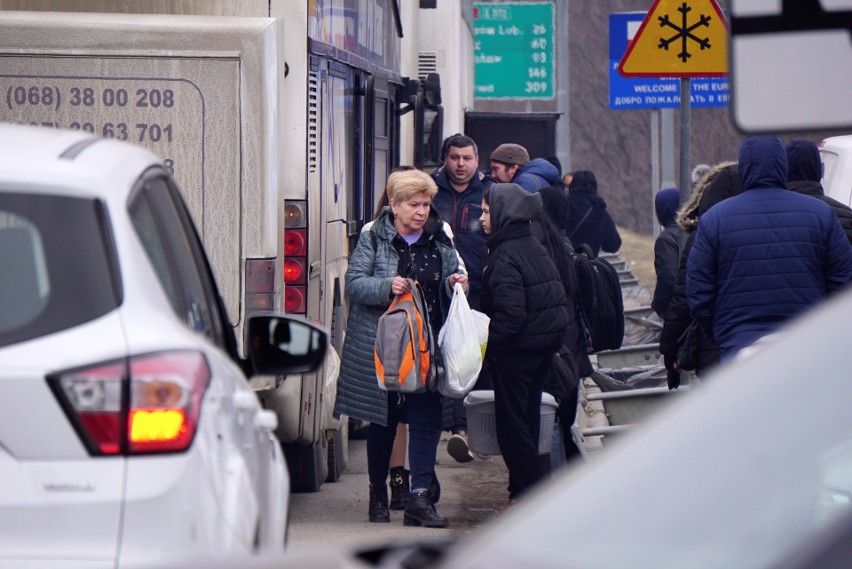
[288,433,508,551]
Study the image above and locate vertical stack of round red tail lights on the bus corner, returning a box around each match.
[282,201,308,314]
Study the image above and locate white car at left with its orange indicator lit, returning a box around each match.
[0,124,327,569]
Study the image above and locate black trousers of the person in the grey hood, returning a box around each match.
[488,354,553,500]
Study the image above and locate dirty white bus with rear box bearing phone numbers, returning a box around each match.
[0,0,452,491]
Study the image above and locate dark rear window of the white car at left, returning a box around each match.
[0,191,121,346]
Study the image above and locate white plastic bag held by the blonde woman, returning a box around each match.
[438,283,490,399]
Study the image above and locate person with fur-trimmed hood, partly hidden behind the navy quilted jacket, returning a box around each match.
[660,162,742,389]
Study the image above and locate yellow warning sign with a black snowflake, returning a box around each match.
[618,0,728,77]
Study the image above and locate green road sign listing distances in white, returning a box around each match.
[473,2,556,99]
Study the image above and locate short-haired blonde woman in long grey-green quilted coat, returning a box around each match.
[335,166,467,528]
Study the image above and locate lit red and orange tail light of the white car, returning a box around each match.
[48,352,210,455]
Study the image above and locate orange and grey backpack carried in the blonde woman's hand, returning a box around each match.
[373,279,441,393]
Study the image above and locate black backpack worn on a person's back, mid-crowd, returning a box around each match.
[574,244,624,354]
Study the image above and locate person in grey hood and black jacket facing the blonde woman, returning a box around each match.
[480,184,568,504]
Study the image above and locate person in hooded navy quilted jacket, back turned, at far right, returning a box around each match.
[686,136,852,360]
